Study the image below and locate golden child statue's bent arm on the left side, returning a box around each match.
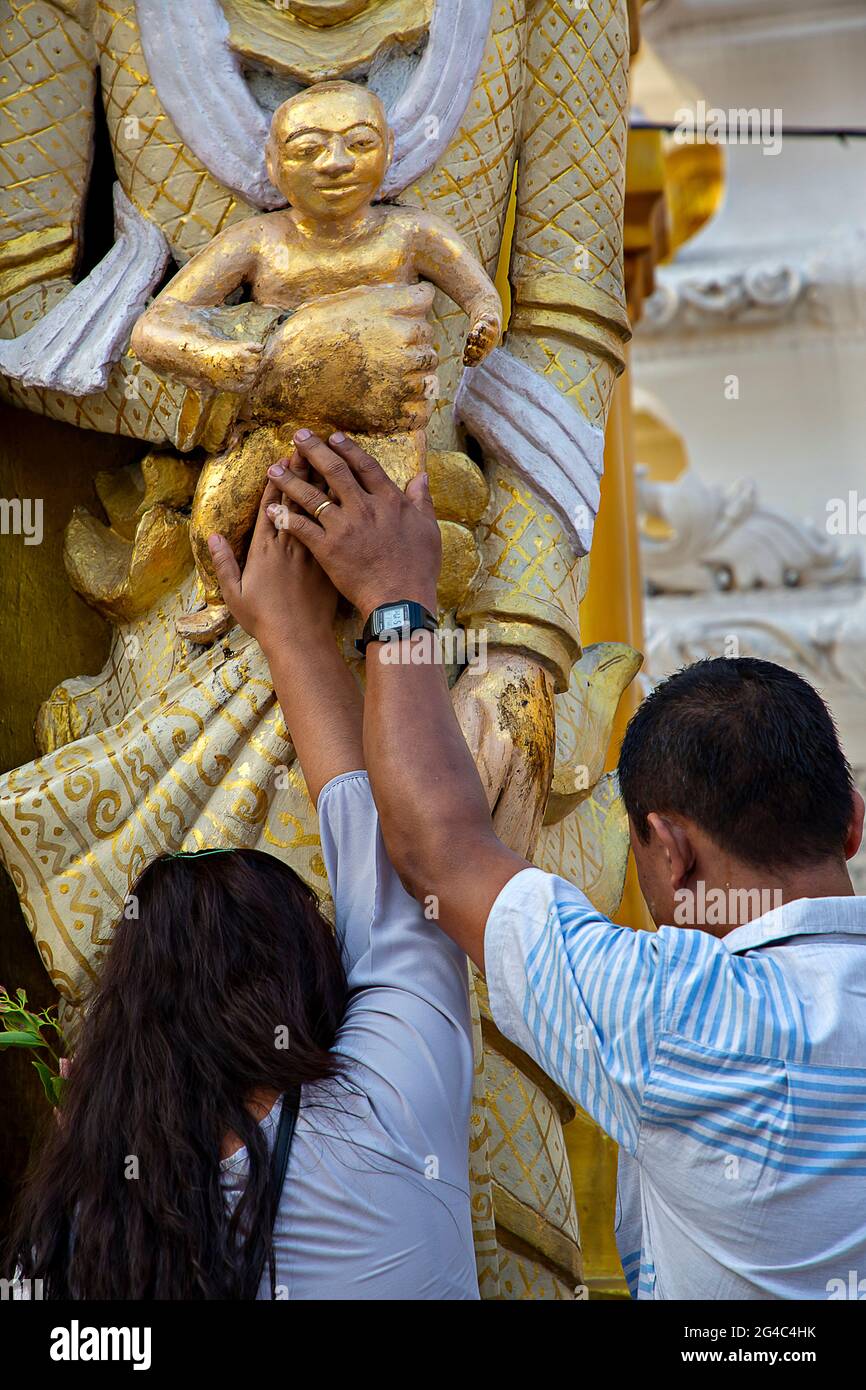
[131,221,261,391]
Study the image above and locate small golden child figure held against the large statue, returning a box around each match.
[132,82,502,642]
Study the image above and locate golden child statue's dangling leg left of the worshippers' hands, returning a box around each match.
[178,427,291,642]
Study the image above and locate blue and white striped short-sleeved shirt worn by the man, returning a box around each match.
[485,869,866,1300]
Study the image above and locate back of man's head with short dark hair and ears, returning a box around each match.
[619,657,856,935]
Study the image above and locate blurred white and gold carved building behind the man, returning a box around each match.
[632,0,866,891]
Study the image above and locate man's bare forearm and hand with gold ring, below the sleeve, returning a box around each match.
[261,435,527,969]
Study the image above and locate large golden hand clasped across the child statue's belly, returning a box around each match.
[246,284,436,434]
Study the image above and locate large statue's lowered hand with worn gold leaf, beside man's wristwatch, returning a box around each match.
[453,648,556,858]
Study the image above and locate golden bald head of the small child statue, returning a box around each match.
[268,82,393,218]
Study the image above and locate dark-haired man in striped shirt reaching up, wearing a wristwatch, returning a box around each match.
[219,435,866,1300]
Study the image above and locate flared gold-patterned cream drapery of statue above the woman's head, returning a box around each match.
[0,581,337,1002]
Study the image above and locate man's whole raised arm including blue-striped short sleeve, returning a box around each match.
[254,431,675,1154]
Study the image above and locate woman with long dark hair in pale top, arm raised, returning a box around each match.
[13,455,478,1300]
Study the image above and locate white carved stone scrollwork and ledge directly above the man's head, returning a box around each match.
[638,473,866,892]
